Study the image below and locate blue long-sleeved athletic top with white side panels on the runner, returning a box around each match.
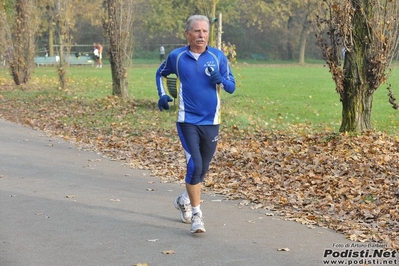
[156,46,235,125]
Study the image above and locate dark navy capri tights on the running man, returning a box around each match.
[176,123,219,185]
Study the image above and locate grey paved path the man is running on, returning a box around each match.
[0,119,356,266]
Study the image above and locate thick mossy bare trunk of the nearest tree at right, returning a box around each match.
[340,0,374,132]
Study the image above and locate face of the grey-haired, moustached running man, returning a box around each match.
[186,20,209,53]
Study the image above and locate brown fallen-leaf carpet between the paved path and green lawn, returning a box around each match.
[0,88,399,250]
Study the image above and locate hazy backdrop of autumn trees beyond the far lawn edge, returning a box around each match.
[25,0,328,61]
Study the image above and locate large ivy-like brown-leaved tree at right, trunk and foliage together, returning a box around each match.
[318,0,399,132]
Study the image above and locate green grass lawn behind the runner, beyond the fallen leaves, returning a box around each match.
[0,61,399,134]
